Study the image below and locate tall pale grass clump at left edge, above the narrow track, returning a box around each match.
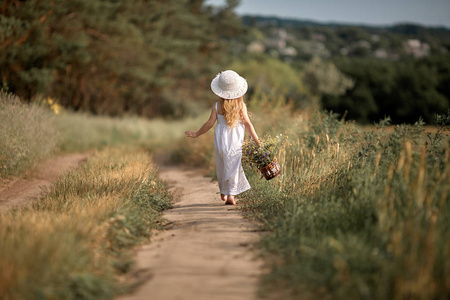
[0,90,58,178]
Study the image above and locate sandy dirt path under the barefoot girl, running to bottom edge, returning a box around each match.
[119,168,261,300]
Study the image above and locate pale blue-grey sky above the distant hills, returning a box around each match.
[206,0,450,28]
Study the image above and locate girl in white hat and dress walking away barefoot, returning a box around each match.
[185,70,260,205]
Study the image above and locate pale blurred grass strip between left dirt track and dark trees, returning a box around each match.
[0,92,206,178]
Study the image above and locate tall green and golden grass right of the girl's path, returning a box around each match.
[237,108,450,299]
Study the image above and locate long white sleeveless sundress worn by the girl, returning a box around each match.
[214,102,250,196]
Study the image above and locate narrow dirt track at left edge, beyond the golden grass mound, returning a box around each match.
[0,153,89,213]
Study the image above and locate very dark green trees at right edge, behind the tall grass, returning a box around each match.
[322,55,450,124]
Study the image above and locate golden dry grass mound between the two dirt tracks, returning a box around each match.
[0,149,171,300]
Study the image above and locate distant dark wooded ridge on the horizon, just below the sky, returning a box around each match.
[242,15,450,59]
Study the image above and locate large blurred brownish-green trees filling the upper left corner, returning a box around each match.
[0,0,241,117]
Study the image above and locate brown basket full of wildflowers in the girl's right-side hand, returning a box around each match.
[242,134,283,180]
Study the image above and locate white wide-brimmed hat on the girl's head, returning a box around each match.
[211,70,248,99]
